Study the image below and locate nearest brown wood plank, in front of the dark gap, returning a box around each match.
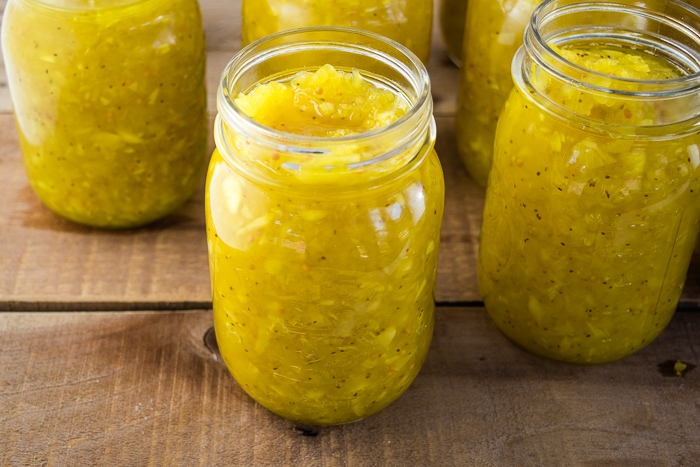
[0,308,700,466]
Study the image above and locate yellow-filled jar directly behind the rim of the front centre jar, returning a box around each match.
[241,0,433,63]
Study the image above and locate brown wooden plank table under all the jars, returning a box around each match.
[0,0,700,466]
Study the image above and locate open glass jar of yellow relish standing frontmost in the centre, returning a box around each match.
[205,28,444,425]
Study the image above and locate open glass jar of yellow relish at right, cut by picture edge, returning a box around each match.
[478,0,700,363]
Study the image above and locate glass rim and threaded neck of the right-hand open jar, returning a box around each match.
[511,0,700,133]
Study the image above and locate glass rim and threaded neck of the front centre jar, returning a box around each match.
[214,27,435,183]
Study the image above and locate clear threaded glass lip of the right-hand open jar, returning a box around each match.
[524,0,700,96]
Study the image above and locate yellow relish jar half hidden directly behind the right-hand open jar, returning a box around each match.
[455,0,541,187]
